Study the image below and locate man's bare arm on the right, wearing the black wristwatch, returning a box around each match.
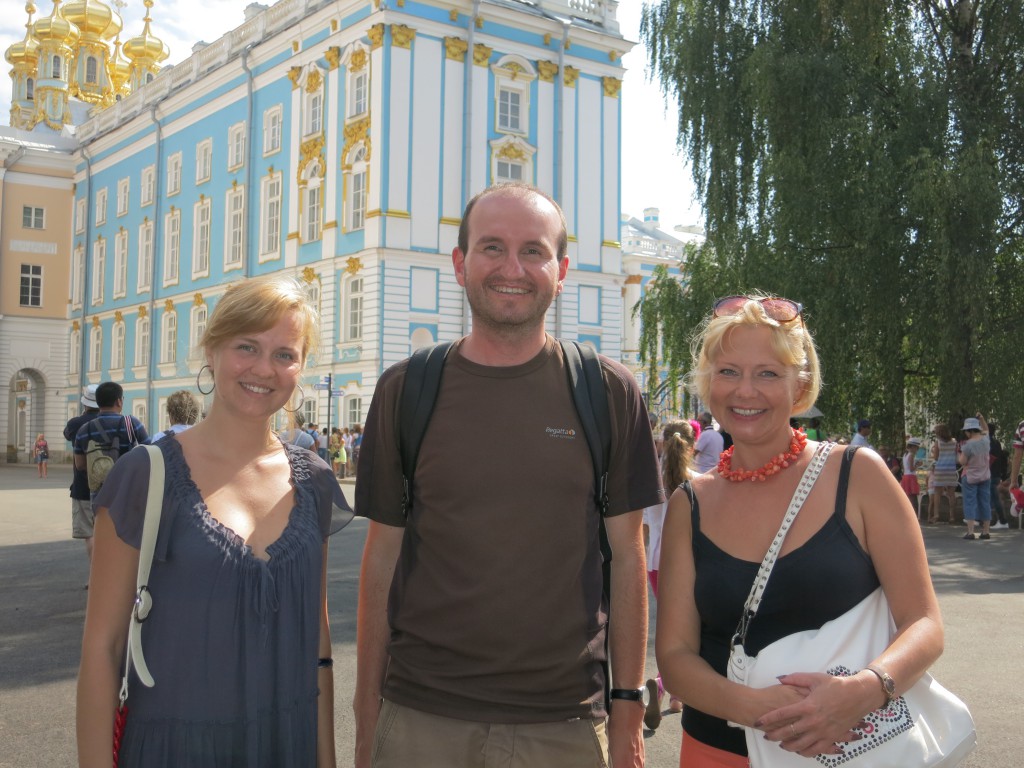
[604,510,647,768]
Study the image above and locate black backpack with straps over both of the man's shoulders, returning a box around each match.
[398,340,611,703]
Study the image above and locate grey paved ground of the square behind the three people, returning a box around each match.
[0,464,1024,768]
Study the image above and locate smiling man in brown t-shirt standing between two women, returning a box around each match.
[353,185,660,768]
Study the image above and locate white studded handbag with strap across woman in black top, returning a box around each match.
[727,444,977,768]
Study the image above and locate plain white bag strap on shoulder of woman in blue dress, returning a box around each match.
[120,445,164,703]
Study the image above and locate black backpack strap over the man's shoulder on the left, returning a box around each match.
[398,341,455,517]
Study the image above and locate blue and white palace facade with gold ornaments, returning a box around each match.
[66,0,632,431]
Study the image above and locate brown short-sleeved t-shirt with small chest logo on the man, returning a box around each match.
[356,337,660,723]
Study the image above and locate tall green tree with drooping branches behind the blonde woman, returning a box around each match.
[637,0,1024,441]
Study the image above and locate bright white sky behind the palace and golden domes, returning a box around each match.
[0,0,701,229]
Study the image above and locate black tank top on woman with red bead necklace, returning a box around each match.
[682,446,879,755]
